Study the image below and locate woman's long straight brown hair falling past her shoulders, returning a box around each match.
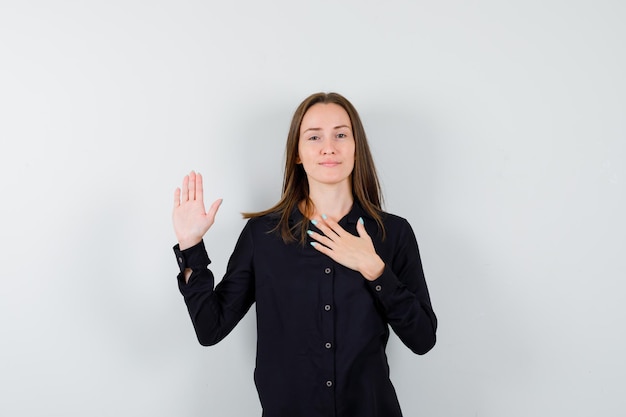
[243,93,385,244]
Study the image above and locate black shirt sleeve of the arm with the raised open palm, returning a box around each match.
[174,223,255,346]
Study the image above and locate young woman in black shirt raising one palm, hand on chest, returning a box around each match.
[173,93,437,417]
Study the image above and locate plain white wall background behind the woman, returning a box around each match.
[0,0,626,417]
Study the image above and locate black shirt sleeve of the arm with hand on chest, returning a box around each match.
[368,219,437,355]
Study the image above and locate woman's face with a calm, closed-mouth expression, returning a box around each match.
[297,103,355,187]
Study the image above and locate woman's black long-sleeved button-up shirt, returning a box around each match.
[174,203,437,417]
